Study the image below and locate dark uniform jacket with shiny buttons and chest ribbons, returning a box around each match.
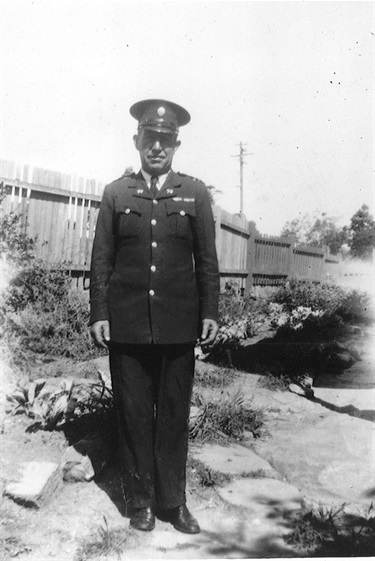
[90,171,220,344]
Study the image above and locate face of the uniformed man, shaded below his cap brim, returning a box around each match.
[133,129,181,175]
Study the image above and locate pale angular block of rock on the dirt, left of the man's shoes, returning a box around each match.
[5,461,63,508]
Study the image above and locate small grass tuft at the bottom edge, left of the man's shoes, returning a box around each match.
[74,516,136,561]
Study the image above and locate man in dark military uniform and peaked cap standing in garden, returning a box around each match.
[90,99,219,533]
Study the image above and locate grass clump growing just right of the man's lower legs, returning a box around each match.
[190,384,265,443]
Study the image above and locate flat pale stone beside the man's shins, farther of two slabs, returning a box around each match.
[190,444,278,478]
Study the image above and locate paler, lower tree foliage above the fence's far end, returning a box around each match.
[281,213,348,253]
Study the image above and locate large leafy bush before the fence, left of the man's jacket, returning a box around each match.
[0,261,99,360]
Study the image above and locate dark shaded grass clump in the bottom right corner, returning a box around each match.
[285,503,375,557]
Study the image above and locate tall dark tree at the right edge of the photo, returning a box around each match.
[349,204,375,260]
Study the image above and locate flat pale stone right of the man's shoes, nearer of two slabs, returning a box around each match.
[217,478,303,519]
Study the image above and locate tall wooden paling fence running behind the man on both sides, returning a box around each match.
[0,160,341,292]
